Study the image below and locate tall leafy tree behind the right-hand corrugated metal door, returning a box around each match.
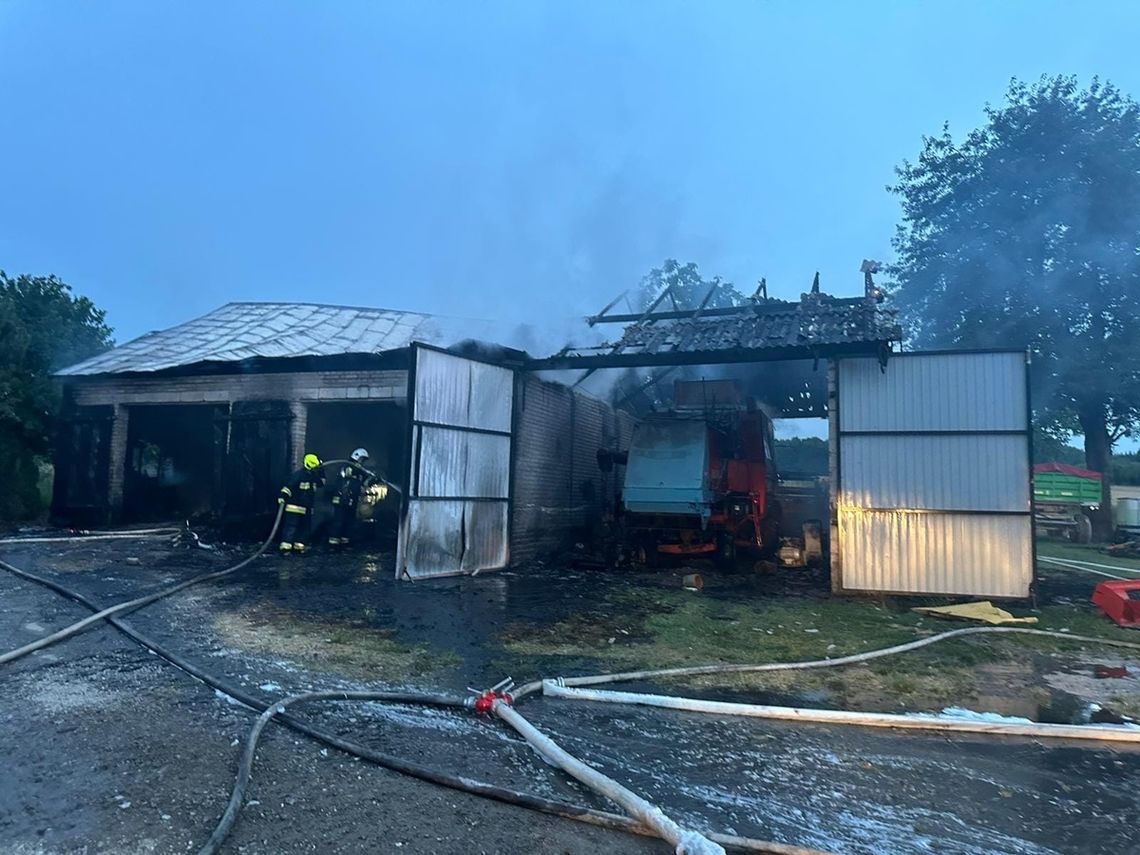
[889,76,1140,535]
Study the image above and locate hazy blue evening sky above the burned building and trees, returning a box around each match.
[0,0,1140,341]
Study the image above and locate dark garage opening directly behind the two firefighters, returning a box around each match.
[304,401,408,548]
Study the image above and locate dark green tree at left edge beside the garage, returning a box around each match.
[0,270,112,520]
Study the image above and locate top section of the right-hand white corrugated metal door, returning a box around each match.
[839,352,1027,431]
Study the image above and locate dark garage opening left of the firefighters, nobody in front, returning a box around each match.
[123,404,226,522]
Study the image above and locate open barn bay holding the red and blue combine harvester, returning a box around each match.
[601,359,830,568]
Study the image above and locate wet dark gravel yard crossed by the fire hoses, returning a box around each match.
[0,542,1140,855]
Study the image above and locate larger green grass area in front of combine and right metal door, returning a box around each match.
[502,589,1140,711]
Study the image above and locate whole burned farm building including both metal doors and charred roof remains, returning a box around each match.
[54,285,1034,597]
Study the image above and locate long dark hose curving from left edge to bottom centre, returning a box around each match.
[0,560,829,855]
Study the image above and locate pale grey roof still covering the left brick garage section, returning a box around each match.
[58,303,503,376]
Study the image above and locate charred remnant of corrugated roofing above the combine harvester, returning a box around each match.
[614,294,902,353]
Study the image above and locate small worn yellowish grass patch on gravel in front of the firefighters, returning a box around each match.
[214,610,459,681]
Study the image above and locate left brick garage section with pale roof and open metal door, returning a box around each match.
[52,303,629,577]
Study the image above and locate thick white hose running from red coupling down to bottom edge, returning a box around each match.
[491,700,724,855]
